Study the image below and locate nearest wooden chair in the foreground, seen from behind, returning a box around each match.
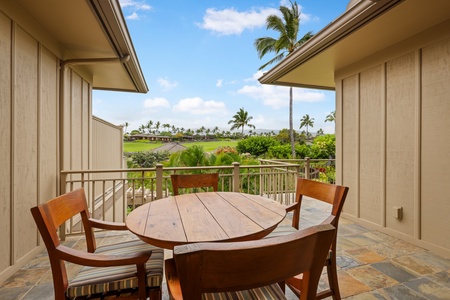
[165,224,336,300]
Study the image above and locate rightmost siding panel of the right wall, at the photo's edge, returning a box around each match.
[421,39,450,249]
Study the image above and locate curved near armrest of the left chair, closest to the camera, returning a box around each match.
[56,245,152,267]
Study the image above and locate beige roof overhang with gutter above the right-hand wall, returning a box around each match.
[259,0,450,90]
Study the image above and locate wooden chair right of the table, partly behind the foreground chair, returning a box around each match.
[266,178,348,300]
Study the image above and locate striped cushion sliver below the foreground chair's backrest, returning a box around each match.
[202,284,287,300]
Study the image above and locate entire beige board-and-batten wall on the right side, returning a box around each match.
[336,21,450,256]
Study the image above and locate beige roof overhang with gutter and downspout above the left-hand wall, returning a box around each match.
[6,0,148,93]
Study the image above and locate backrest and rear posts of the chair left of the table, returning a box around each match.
[31,188,96,291]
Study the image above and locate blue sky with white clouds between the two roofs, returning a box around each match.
[93,0,348,133]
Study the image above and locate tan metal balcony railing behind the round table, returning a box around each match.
[61,159,334,238]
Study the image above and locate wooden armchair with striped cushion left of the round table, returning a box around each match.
[31,189,164,300]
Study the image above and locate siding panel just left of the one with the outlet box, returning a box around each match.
[359,66,383,225]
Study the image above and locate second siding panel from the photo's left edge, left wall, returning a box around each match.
[13,27,39,261]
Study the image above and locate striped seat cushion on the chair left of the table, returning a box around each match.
[66,240,164,297]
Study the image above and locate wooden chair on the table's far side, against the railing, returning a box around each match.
[170,173,219,196]
